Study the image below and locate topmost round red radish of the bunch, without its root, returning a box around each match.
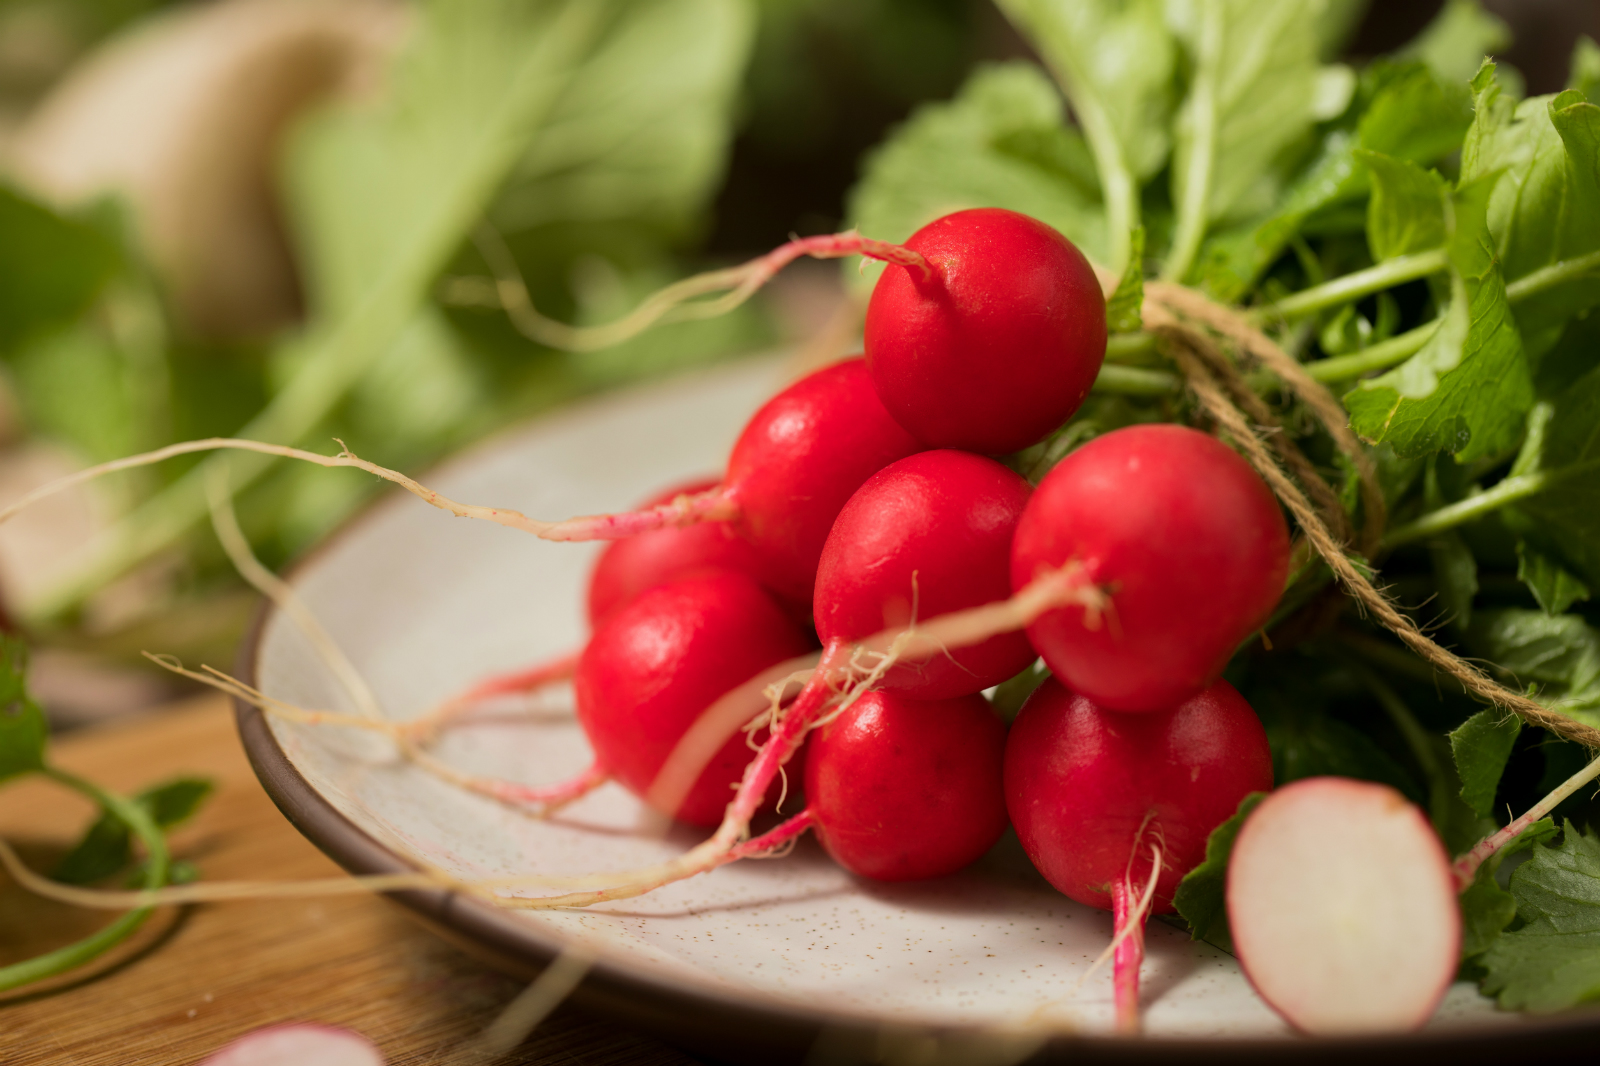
[866,208,1106,455]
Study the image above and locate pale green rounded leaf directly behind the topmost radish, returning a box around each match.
[846,62,1106,287]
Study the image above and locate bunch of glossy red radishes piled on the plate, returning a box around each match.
[438,210,1324,1029]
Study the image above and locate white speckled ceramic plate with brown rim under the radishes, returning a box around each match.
[240,360,1574,1061]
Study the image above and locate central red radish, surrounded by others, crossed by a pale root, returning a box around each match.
[813,450,1035,699]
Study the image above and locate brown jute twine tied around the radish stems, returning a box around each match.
[1142,282,1600,749]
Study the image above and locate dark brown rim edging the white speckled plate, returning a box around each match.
[232,359,1600,1066]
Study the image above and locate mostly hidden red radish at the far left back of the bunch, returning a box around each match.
[589,477,758,627]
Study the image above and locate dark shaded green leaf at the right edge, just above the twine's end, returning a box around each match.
[1501,367,1600,585]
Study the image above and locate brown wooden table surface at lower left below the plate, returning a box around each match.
[0,696,694,1066]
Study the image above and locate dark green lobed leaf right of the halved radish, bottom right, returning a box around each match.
[1482,823,1600,1013]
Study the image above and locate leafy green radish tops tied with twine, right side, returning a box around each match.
[851,0,1600,1010]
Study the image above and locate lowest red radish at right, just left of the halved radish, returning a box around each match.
[1005,679,1272,914]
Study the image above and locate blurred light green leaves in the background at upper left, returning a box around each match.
[0,0,770,655]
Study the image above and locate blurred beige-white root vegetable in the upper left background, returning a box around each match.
[6,0,405,338]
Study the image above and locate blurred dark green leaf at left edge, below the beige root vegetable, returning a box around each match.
[0,184,122,352]
